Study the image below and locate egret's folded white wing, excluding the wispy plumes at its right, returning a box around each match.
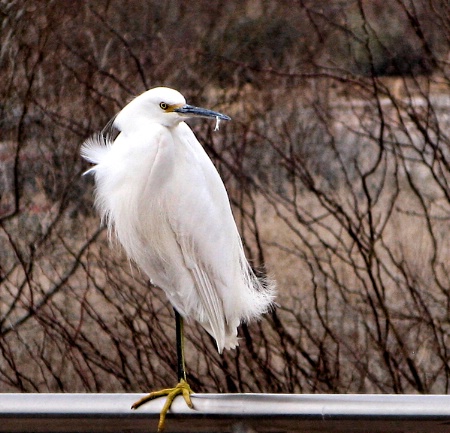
[166,124,242,351]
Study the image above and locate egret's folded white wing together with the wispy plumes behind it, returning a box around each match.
[168,124,275,352]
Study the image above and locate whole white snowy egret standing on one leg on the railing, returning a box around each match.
[81,87,274,430]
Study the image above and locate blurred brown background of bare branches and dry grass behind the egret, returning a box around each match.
[0,0,450,393]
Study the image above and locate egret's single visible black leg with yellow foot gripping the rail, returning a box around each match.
[131,309,194,432]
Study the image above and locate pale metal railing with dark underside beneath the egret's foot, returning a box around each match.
[0,394,450,433]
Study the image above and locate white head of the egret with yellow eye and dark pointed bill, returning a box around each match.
[114,87,230,131]
